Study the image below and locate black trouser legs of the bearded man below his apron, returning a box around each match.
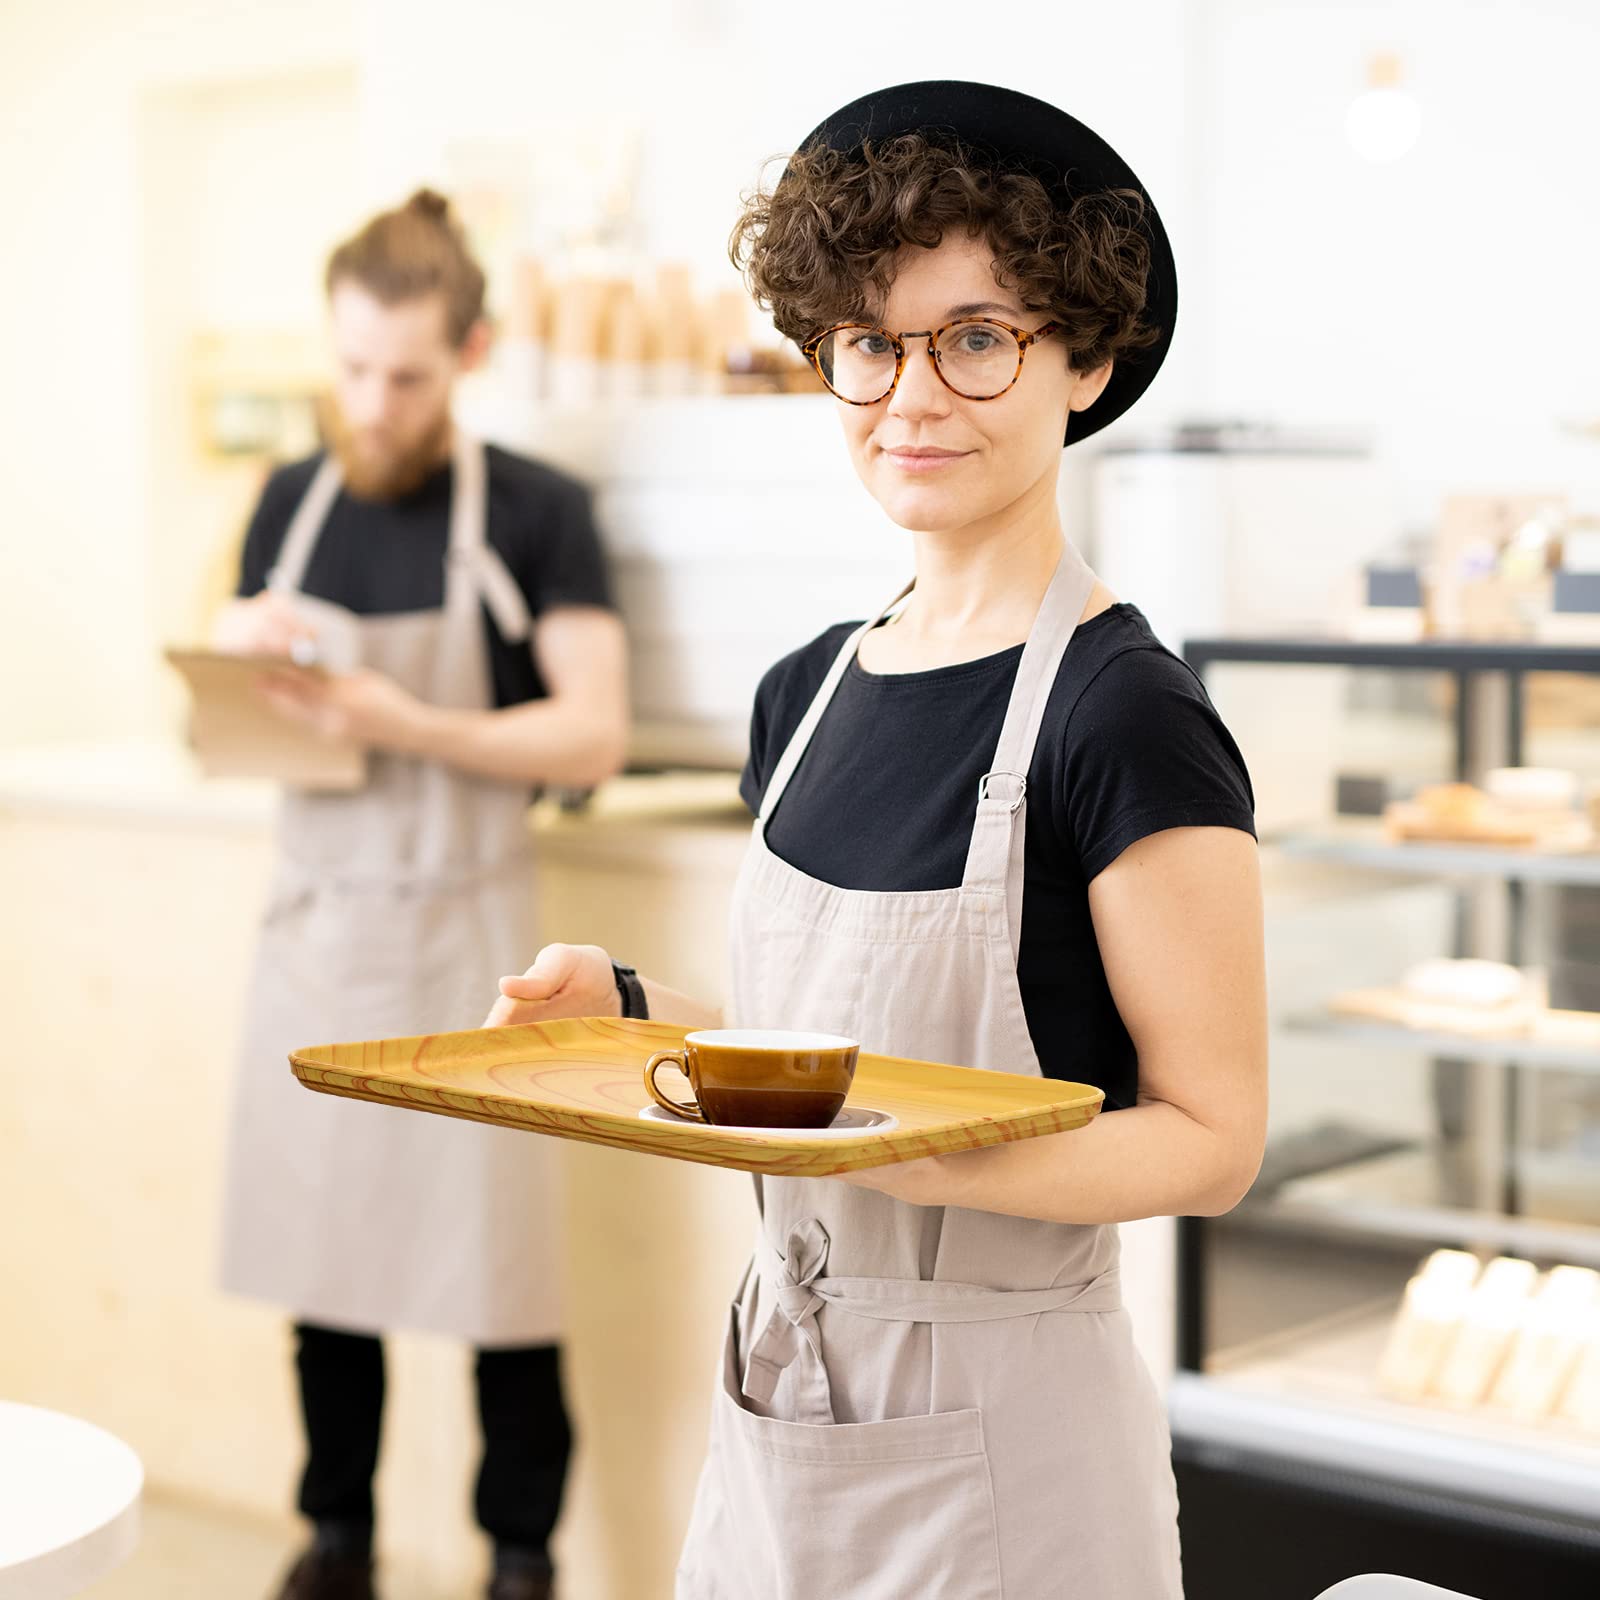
[294,1323,573,1554]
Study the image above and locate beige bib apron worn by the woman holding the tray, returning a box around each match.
[677,547,1182,1600]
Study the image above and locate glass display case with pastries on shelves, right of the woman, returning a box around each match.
[1171,638,1600,1600]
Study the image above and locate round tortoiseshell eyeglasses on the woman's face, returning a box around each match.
[800,317,1061,405]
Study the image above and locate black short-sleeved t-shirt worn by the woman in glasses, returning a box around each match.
[741,602,1256,1110]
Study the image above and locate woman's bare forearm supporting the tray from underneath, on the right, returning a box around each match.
[856,1101,1261,1222]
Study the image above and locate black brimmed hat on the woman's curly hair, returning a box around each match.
[800,80,1178,445]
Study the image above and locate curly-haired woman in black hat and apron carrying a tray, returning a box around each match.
[491,83,1266,1600]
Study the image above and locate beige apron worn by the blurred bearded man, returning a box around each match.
[222,437,562,1346]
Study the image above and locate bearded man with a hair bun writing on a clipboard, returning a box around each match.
[214,190,627,1600]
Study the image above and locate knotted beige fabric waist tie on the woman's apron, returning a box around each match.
[742,1216,1122,1424]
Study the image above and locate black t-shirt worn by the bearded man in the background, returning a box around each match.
[238,445,611,706]
